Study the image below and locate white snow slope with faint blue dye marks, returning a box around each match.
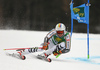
[0,30,100,70]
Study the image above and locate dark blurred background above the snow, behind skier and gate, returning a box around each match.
[0,0,100,33]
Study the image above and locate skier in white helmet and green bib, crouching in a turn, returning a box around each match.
[15,23,71,59]
